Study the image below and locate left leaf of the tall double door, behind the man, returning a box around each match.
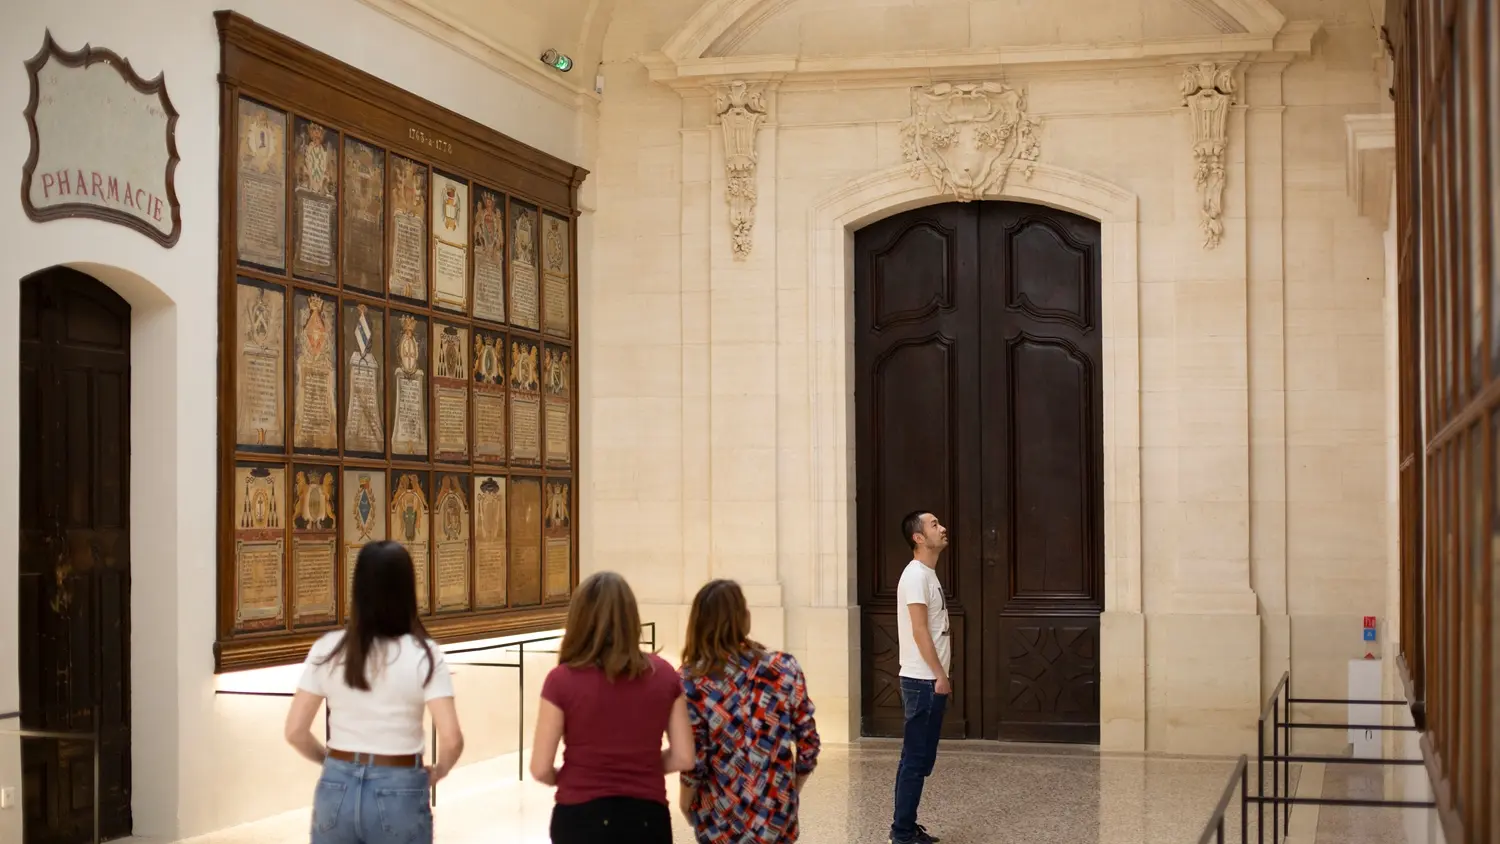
[855,205,983,738]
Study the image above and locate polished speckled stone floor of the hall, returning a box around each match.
[135,741,1385,844]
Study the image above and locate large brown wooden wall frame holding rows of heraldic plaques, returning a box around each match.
[215,12,588,672]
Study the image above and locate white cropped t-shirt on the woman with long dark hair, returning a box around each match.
[297,631,453,756]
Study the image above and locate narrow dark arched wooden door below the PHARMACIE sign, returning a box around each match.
[20,268,132,844]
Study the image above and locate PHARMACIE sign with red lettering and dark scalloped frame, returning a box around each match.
[21,33,182,247]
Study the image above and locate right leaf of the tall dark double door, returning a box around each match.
[980,202,1104,742]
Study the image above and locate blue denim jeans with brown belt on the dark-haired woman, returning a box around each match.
[312,759,432,844]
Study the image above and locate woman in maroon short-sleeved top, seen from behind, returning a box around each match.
[531,571,695,844]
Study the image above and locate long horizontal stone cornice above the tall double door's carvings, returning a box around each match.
[639,22,1322,94]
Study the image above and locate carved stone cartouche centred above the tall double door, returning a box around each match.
[902,82,1041,202]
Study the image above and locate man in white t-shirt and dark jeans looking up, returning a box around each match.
[891,511,953,844]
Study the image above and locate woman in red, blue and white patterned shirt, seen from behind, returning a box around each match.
[681,580,819,844]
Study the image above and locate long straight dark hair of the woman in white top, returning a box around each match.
[320,540,437,691]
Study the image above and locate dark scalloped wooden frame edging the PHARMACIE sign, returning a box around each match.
[21,30,183,249]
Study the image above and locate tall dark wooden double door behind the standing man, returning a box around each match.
[854,202,1104,744]
